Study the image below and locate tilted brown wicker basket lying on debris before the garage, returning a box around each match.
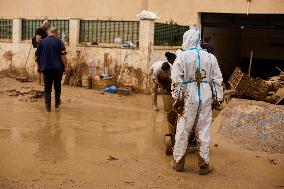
[228,68,268,101]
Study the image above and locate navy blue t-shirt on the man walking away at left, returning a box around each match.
[36,35,66,72]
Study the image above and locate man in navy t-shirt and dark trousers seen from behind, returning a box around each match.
[36,27,67,112]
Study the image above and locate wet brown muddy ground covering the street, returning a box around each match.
[0,78,284,189]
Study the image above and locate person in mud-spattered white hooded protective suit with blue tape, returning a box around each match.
[171,27,223,175]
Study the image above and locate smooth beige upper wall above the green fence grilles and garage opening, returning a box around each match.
[0,0,284,25]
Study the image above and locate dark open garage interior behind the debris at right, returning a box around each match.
[201,13,284,83]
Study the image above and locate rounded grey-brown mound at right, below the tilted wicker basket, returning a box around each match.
[219,98,284,153]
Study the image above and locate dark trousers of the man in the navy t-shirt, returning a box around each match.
[43,70,63,107]
